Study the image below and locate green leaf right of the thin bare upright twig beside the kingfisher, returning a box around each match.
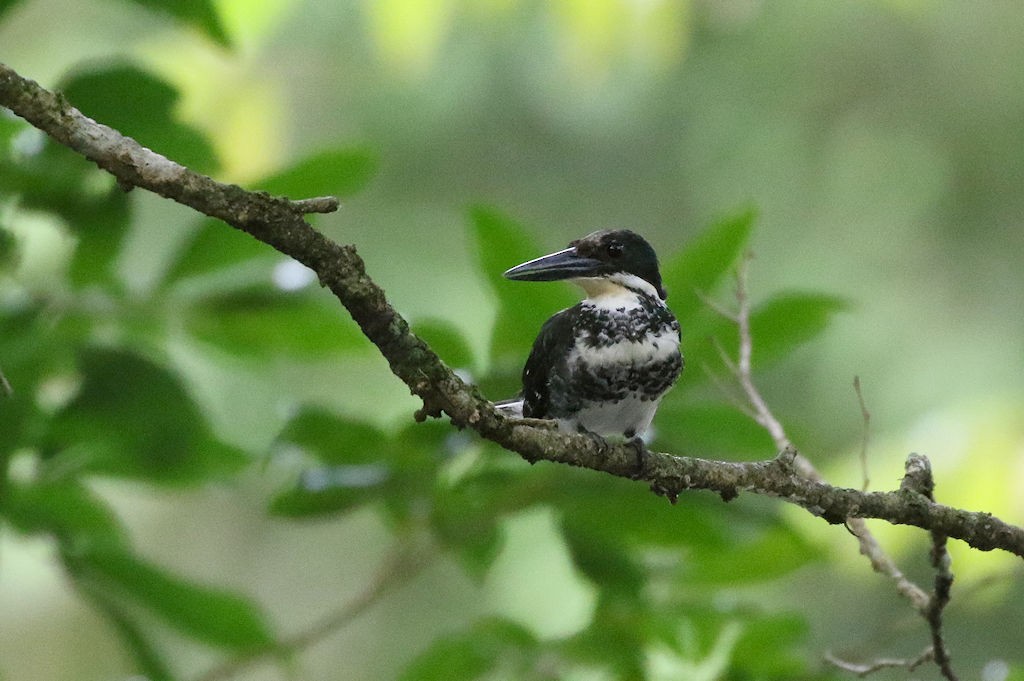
[751,293,849,368]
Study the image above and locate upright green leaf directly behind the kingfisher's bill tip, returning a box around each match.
[471,208,575,370]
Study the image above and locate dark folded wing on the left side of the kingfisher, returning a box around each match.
[522,307,574,419]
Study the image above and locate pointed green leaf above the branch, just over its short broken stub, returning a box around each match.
[255,148,377,199]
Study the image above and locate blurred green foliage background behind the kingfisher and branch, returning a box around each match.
[0,0,1024,681]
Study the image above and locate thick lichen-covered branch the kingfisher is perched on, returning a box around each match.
[0,65,1024,557]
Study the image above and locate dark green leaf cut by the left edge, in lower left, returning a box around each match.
[0,480,128,551]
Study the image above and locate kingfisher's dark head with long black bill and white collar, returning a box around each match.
[505,229,668,300]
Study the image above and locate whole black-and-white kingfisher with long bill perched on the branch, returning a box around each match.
[498,229,683,439]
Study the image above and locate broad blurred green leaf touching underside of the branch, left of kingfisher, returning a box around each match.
[185,289,369,359]
